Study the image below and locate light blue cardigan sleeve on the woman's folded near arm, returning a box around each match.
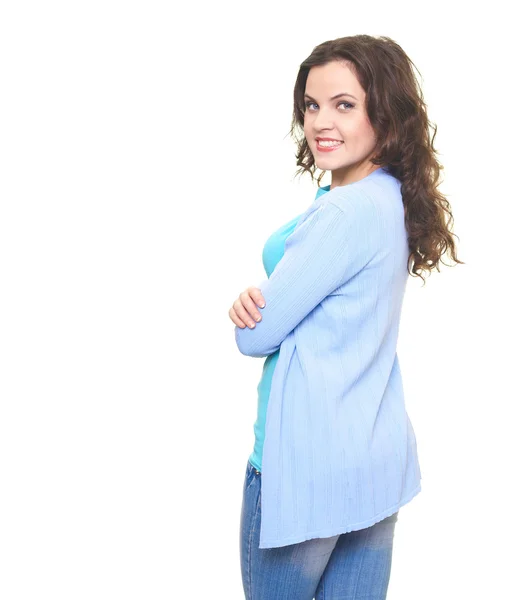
[235,192,382,357]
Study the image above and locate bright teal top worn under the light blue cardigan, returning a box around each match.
[249,185,330,471]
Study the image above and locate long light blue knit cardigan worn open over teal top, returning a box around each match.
[235,168,421,548]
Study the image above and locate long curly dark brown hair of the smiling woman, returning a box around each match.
[289,35,465,285]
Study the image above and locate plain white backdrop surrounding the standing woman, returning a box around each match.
[0,0,520,600]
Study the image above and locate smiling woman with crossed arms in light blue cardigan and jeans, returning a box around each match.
[229,35,463,600]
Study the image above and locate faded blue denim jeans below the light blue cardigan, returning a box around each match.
[240,460,398,600]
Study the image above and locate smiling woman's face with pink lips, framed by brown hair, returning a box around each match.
[304,61,378,189]
